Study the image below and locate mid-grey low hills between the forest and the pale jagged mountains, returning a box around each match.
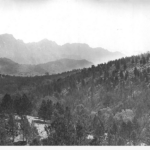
[0,58,92,75]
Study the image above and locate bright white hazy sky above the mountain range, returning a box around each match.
[0,0,150,55]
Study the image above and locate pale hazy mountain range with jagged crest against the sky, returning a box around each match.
[0,34,123,64]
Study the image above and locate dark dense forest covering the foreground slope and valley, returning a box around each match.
[0,53,150,145]
